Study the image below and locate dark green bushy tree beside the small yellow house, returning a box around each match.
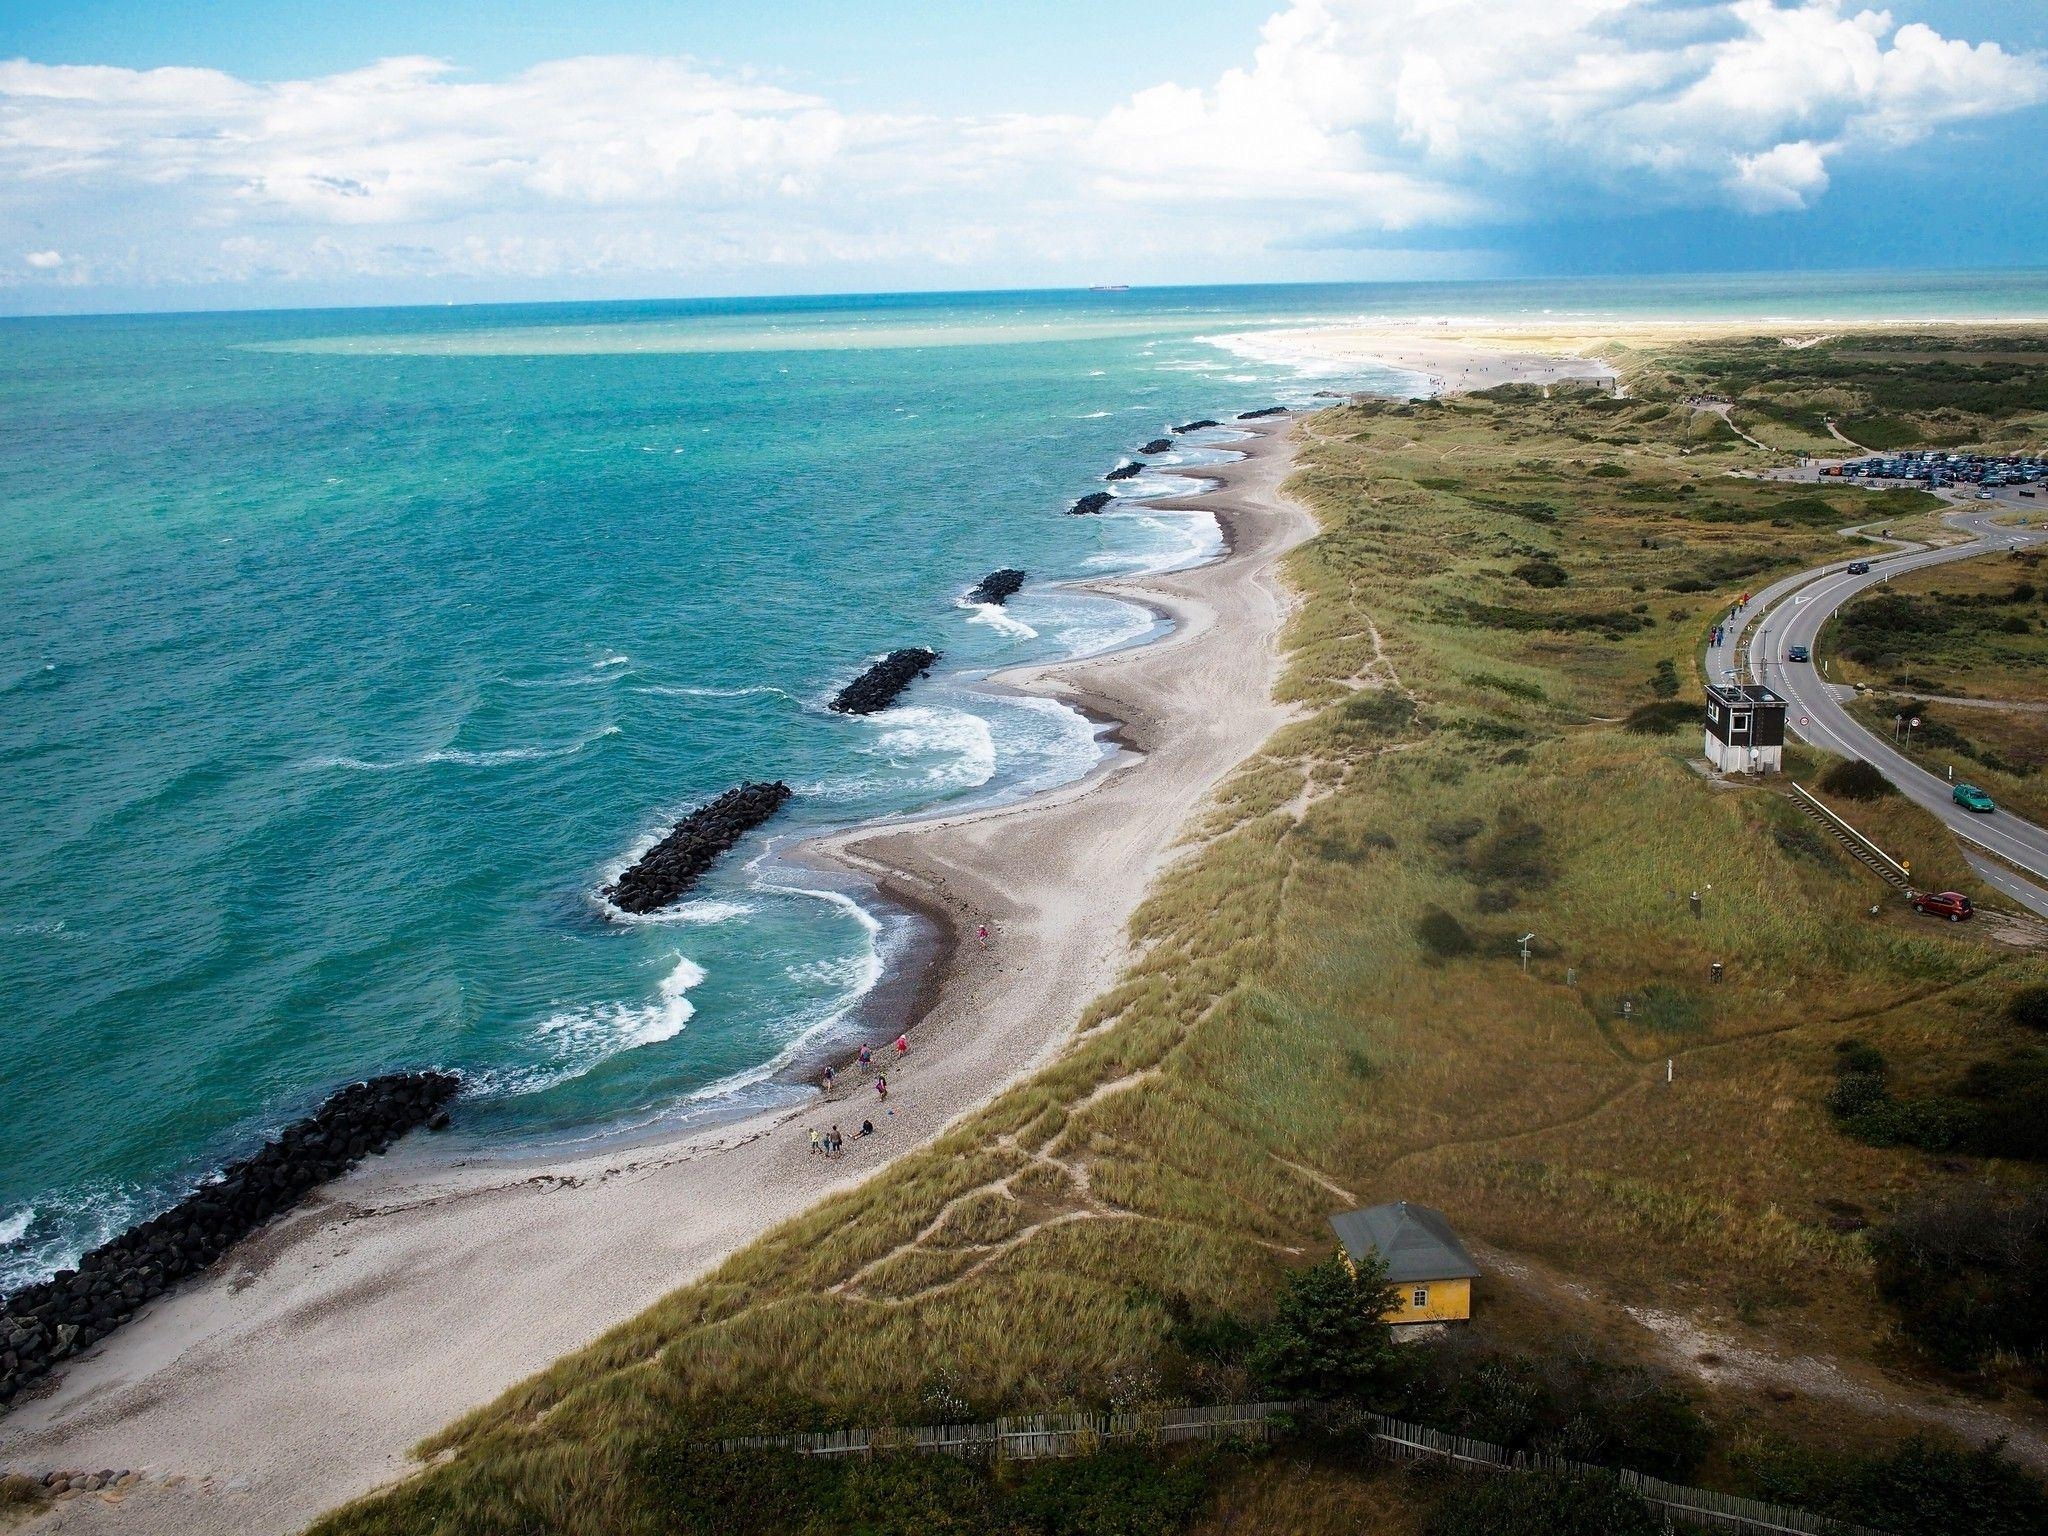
[1251,1255,1401,1397]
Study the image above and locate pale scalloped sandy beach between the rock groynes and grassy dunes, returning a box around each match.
[0,418,1313,1536]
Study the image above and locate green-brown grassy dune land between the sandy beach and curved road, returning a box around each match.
[319,348,2048,1536]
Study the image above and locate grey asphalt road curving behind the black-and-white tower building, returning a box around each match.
[1706,502,2048,918]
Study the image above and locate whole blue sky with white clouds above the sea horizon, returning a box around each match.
[0,0,2048,313]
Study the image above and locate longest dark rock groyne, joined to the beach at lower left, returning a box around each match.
[0,1071,463,1407]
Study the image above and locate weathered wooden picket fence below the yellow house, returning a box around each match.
[719,1403,1878,1536]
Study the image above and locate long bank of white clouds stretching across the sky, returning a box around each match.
[0,0,2048,296]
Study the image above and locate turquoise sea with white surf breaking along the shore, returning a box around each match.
[0,274,2048,1290]
